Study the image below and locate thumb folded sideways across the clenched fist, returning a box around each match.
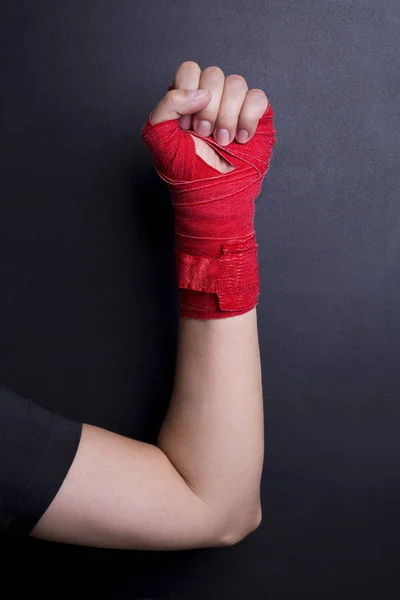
[150,89,211,125]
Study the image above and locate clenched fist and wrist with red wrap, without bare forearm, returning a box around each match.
[142,61,276,319]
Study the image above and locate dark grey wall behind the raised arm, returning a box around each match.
[0,0,400,600]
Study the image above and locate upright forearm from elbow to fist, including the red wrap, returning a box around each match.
[147,61,276,531]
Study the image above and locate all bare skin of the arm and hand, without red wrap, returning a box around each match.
[32,61,268,550]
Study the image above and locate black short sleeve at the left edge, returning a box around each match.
[0,384,82,535]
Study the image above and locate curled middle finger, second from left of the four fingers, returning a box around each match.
[192,67,225,137]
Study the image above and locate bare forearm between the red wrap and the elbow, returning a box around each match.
[158,308,264,526]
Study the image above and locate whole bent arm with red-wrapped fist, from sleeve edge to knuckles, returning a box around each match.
[20,61,275,550]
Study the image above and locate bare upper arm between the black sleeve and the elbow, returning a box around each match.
[31,425,225,550]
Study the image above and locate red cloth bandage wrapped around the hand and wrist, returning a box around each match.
[142,86,276,319]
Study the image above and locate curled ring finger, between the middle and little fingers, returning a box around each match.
[213,75,249,146]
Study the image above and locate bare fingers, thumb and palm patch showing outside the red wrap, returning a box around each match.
[151,61,268,173]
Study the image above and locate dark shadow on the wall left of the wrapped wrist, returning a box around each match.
[130,161,179,443]
